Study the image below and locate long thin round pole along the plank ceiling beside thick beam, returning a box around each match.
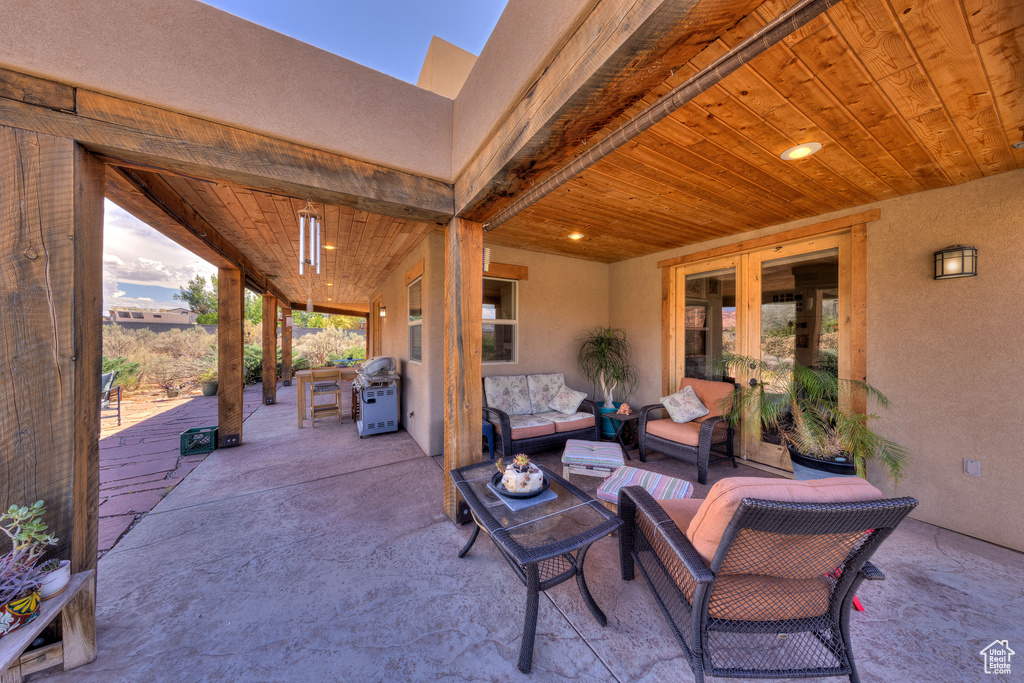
[479,0,840,230]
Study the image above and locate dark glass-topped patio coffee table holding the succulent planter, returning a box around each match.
[452,462,623,674]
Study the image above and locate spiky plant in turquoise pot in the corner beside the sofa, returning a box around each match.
[577,327,639,436]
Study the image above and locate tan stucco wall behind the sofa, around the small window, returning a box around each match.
[482,245,608,398]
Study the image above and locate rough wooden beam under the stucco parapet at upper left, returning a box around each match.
[0,69,454,224]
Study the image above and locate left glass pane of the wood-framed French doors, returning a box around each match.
[680,268,736,381]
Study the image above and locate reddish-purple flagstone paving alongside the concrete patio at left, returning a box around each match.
[99,384,263,556]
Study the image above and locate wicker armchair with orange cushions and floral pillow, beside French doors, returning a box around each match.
[637,378,736,483]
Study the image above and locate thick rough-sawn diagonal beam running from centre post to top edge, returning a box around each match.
[455,0,762,221]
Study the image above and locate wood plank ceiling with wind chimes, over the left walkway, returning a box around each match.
[144,175,433,310]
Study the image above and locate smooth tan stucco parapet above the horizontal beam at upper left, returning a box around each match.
[0,0,452,180]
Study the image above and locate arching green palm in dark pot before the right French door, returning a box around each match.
[717,354,907,484]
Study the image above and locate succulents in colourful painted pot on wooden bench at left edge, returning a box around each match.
[0,501,57,637]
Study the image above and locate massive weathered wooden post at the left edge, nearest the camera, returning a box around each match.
[0,126,104,593]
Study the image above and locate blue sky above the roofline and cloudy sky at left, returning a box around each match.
[103,0,507,308]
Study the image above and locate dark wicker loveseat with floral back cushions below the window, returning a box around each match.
[483,373,601,458]
